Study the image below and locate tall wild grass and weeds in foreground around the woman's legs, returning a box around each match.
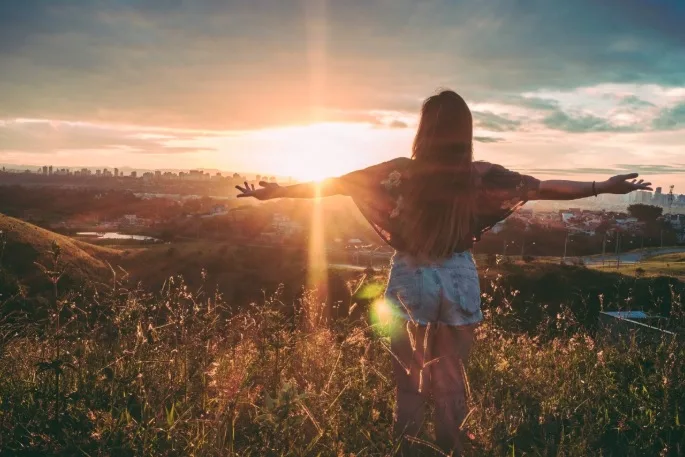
[0,248,685,456]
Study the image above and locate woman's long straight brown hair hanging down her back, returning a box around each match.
[402,90,475,259]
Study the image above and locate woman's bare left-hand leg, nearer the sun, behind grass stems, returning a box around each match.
[390,320,430,455]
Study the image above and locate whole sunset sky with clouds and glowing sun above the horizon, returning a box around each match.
[0,0,685,187]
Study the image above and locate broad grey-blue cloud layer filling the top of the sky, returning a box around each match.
[0,0,685,129]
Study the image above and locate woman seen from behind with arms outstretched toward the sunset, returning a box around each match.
[236,90,651,452]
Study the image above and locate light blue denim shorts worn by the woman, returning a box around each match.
[385,251,483,325]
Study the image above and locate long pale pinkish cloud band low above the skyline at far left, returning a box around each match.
[0,120,214,154]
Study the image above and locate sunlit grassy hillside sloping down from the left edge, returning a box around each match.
[0,214,120,297]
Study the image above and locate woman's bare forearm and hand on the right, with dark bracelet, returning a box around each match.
[530,173,652,200]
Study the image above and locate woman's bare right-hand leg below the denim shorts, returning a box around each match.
[430,324,475,455]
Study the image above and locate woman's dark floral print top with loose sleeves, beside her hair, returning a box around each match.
[339,157,540,251]
